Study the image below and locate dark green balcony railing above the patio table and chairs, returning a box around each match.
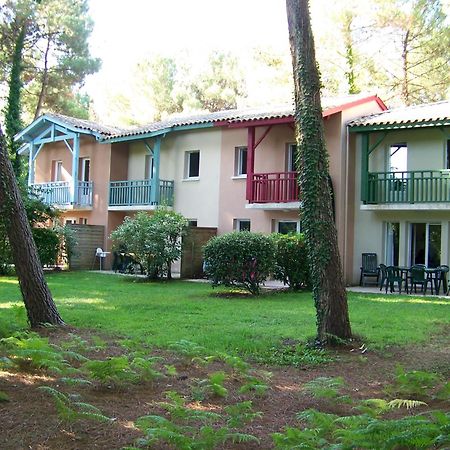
[366,170,450,204]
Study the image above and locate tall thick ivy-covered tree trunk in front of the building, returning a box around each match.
[286,0,352,343]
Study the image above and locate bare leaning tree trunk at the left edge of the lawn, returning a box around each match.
[0,129,64,327]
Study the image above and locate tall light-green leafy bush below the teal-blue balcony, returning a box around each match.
[111,208,188,279]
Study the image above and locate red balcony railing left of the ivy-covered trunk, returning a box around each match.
[249,172,299,203]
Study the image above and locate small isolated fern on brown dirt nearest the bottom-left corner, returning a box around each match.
[38,386,113,423]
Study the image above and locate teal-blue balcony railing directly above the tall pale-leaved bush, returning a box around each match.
[109,180,174,211]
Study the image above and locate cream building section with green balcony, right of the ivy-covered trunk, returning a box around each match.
[349,101,450,283]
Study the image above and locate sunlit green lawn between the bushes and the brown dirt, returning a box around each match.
[0,272,450,355]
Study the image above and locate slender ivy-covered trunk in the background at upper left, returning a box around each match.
[5,21,27,179]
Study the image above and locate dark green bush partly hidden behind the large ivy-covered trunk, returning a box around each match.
[273,233,310,290]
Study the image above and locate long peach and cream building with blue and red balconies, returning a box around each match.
[16,95,386,281]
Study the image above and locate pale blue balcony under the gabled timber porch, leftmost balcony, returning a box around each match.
[31,181,93,209]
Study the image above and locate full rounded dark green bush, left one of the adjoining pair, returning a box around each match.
[203,231,275,294]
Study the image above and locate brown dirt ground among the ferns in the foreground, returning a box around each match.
[0,328,450,450]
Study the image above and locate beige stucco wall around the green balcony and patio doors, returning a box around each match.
[351,128,450,283]
